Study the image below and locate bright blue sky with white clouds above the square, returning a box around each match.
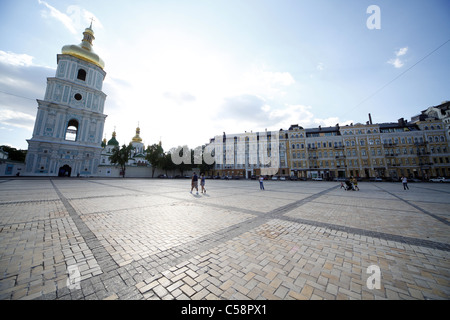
[0,0,450,151]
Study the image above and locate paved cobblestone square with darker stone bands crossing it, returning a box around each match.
[0,177,450,300]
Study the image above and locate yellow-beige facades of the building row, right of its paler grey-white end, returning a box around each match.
[283,119,450,180]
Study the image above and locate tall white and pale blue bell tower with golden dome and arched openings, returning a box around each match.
[25,24,106,176]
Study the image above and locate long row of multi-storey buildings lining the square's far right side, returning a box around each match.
[210,102,450,179]
